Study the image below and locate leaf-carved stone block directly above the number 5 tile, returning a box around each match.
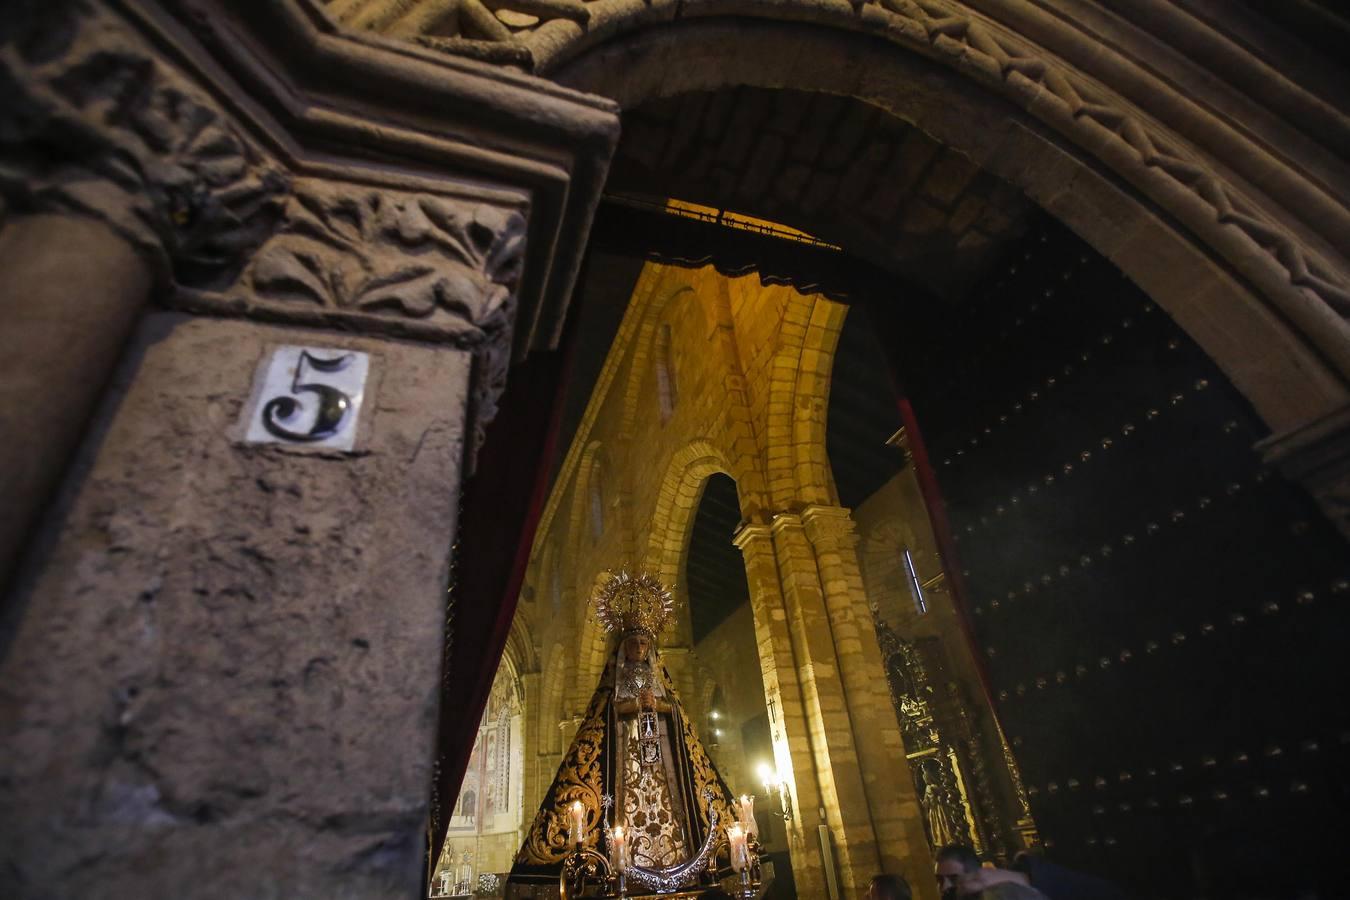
[173,178,525,472]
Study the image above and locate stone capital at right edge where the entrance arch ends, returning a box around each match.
[1257,406,1350,538]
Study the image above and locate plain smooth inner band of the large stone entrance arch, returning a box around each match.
[554,20,1350,432]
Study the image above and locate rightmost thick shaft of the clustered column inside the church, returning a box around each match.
[802,506,932,896]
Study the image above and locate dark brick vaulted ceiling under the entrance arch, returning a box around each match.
[608,88,1035,297]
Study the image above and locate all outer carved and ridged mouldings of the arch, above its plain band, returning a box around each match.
[328,0,1350,388]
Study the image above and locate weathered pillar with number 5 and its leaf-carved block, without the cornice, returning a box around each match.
[0,61,537,897]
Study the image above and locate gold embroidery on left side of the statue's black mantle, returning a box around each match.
[516,664,613,865]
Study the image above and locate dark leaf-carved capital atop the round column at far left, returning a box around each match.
[0,0,288,285]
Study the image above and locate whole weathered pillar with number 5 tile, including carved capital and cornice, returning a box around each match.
[0,0,617,899]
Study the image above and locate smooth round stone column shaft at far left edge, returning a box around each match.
[0,215,151,584]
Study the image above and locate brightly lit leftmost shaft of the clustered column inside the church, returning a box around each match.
[733,524,826,897]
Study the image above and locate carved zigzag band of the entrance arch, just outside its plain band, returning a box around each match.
[328,0,1350,394]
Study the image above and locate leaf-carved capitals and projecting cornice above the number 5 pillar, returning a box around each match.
[0,0,617,468]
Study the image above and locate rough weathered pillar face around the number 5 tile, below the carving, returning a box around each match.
[0,313,471,897]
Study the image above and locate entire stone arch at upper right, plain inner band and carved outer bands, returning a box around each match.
[332,0,1350,433]
